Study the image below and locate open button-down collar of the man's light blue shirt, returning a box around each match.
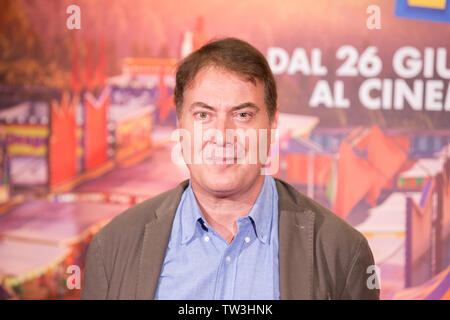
[181,175,278,244]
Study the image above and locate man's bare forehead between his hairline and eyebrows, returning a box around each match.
[184,66,264,108]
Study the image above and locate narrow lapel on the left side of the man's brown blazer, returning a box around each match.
[136,181,189,300]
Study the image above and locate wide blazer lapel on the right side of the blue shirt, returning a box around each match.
[278,181,315,300]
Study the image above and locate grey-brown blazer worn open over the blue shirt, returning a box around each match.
[81,179,379,299]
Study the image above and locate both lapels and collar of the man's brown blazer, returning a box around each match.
[136,179,315,300]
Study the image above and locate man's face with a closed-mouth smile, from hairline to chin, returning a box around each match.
[178,67,277,196]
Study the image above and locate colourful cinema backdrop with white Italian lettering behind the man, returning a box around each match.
[0,0,450,299]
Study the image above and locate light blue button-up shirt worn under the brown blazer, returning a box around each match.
[155,176,280,300]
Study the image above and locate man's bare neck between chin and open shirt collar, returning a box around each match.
[191,175,264,243]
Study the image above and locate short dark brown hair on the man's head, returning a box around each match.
[174,38,277,120]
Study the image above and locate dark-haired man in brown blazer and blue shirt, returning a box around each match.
[81,38,379,299]
